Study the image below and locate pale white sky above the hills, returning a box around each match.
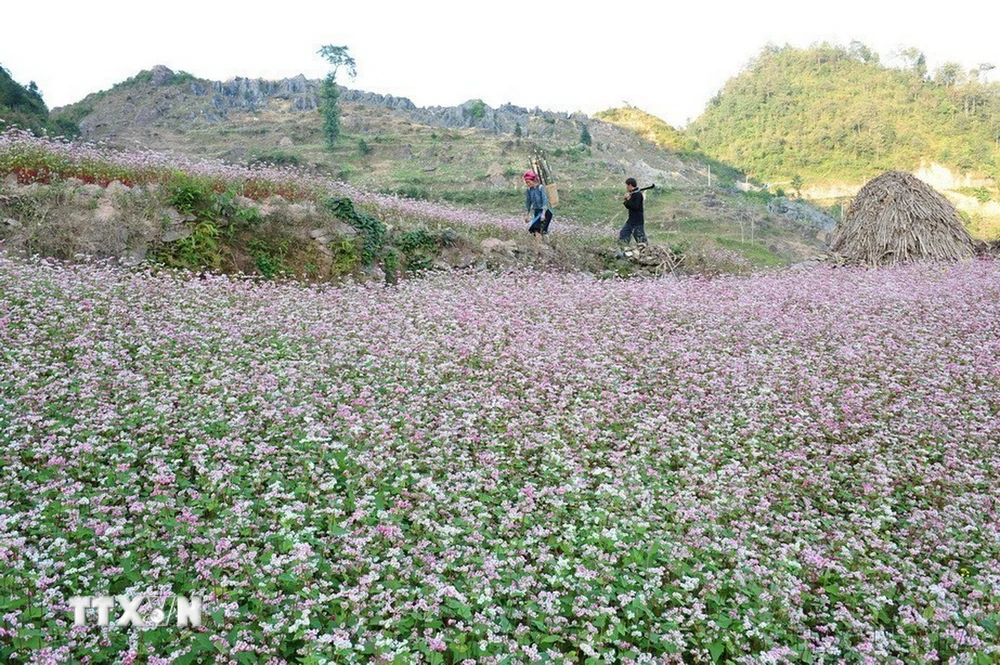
[0,0,1000,126]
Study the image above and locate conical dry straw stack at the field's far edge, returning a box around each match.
[833,171,973,265]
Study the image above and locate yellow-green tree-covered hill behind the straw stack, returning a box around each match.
[688,42,1000,183]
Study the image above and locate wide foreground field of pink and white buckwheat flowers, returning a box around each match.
[0,255,1000,663]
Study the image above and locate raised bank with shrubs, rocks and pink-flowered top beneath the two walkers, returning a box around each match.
[0,130,836,283]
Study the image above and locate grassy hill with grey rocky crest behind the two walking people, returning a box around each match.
[43,67,833,265]
